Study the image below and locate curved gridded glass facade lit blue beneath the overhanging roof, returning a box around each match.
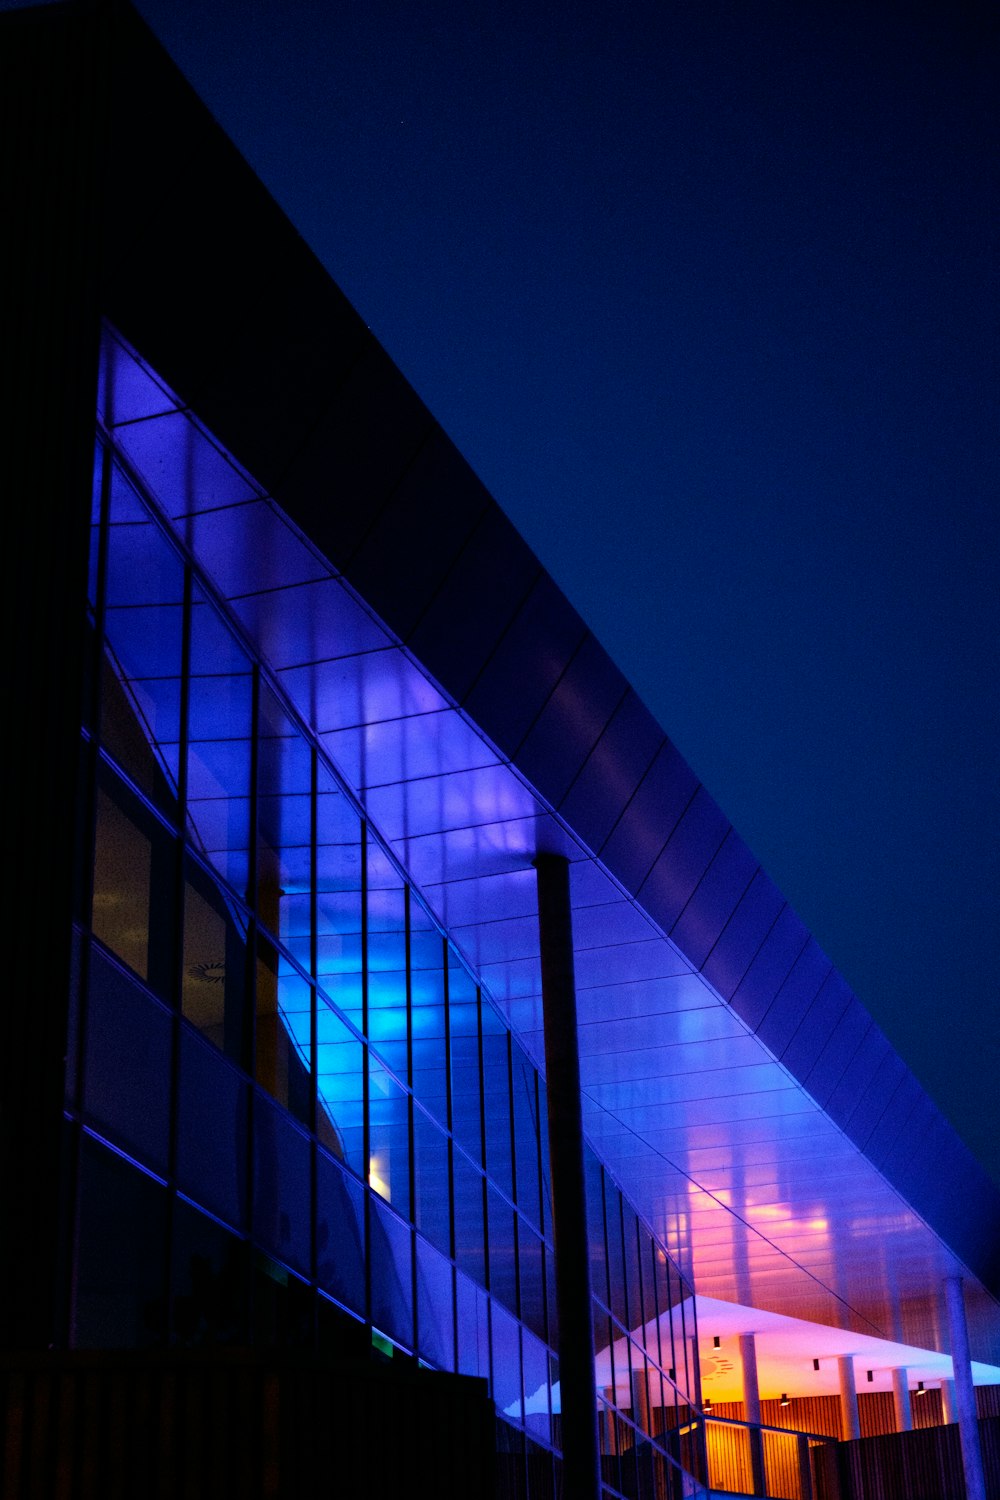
[64,331,702,1497]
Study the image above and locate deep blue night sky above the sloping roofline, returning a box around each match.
[60,0,1000,1181]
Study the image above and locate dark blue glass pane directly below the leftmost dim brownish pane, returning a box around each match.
[84,948,171,1169]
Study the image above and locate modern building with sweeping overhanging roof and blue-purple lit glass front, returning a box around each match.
[0,5,1000,1500]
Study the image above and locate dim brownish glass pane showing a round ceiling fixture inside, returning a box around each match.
[181,860,249,1062]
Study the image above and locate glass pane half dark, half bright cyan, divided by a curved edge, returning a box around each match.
[255,936,312,1125]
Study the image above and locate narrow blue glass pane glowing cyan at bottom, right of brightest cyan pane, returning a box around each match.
[367,839,409,1079]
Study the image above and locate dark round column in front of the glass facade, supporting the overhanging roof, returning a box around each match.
[535,854,601,1500]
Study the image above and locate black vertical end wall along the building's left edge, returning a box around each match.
[0,6,111,1349]
